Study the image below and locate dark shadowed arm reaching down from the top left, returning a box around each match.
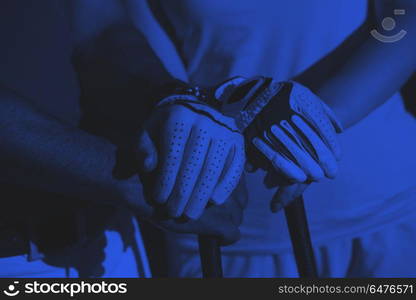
[73,0,177,143]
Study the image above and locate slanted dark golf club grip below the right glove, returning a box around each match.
[285,196,318,278]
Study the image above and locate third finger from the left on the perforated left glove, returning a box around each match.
[184,139,231,219]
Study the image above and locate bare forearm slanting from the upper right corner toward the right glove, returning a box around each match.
[315,12,416,128]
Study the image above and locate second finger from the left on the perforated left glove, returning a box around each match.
[167,127,210,217]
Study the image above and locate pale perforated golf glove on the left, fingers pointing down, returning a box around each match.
[145,83,245,219]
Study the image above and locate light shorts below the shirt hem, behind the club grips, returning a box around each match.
[170,214,416,277]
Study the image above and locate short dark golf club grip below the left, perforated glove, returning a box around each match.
[198,235,223,278]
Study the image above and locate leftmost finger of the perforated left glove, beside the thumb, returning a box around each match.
[153,119,191,204]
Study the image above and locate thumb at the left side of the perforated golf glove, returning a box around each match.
[136,130,157,172]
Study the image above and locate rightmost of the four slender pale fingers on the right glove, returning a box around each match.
[292,116,338,178]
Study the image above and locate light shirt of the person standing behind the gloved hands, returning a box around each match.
[139,0,416,253]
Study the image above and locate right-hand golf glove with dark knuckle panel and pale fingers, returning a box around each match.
[215,77,342,182]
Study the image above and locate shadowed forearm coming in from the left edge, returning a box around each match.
[0,89,151,216]
